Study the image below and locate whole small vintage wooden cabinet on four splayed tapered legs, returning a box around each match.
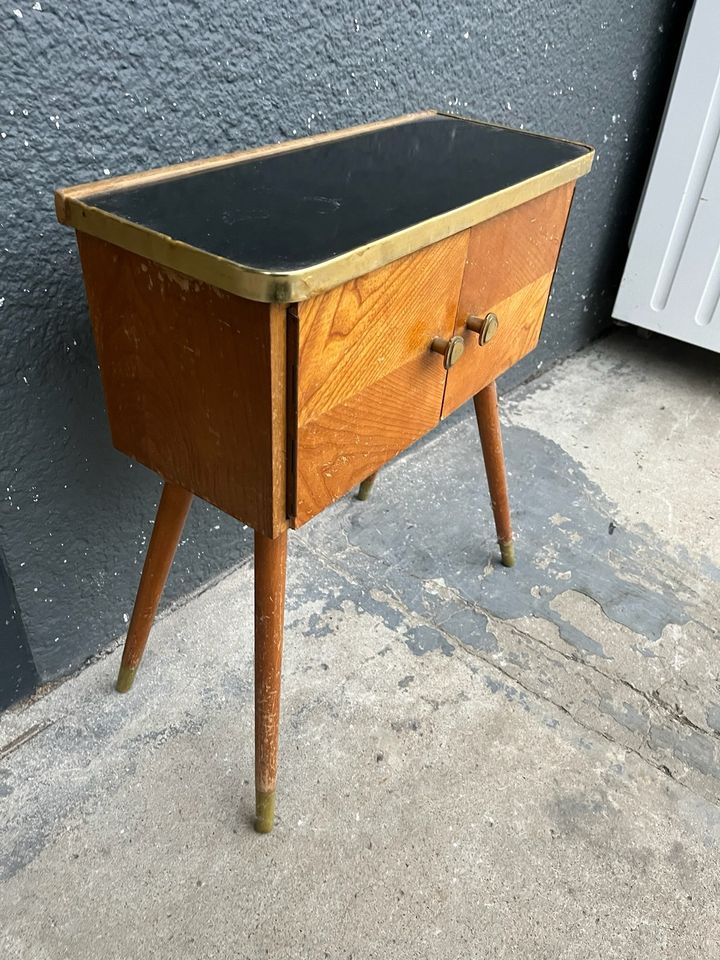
[56,112,593,832]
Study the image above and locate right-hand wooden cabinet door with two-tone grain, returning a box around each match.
[442,183,575,417]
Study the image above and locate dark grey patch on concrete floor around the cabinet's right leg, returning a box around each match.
[304,416,720,658]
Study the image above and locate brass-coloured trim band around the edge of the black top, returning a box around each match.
[56,111,595,303]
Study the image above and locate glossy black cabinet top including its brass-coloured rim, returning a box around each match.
[57,113,593,302]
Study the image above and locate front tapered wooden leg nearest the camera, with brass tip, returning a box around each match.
[255,532,287,833]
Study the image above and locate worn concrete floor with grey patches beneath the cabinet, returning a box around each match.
[0,331,720,960]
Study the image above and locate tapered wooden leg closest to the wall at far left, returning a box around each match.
[115,483,192,693]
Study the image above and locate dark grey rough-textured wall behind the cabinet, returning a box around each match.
[0,0,686,679]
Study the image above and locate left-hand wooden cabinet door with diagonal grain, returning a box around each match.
[288,231,469,526]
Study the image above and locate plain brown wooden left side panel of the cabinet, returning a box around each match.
[78,233,287,537]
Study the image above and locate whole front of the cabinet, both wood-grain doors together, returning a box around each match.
[287,177,574,527]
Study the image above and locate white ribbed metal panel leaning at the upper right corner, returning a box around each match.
[613,0,720,352]
